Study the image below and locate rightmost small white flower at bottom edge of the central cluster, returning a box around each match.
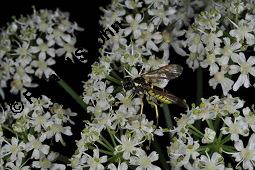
[130,149,161,170]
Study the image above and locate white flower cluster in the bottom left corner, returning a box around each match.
[0,95,77,170]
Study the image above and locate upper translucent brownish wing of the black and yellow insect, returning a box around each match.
[142,64,183,88]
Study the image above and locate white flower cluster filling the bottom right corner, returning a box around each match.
[168,95,255,170]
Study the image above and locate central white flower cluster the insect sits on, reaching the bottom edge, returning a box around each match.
[70,46,166,170]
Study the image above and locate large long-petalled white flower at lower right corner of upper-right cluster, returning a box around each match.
[229,53,255,91]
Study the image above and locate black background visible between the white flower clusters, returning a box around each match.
[0,0,254,167]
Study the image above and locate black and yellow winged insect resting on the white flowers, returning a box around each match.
[122,64,188,118]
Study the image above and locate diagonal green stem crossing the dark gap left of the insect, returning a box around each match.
[57,79,87,111]
